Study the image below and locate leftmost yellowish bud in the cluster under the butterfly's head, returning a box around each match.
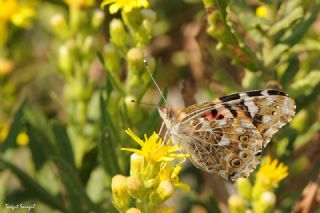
[111,175,131,211]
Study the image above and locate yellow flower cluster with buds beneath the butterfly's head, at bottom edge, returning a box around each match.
[111,129,189,212]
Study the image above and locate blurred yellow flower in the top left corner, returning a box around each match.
[0,0,36,27]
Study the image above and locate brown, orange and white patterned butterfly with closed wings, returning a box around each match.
[158,89,296,182]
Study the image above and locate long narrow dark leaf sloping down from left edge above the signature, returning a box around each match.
[0,157,66,212]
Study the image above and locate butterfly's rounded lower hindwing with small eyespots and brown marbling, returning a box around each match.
[178,117,263,181]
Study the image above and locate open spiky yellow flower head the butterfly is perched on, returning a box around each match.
[121,129,188,162]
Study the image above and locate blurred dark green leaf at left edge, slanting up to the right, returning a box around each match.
[0,100,28,153]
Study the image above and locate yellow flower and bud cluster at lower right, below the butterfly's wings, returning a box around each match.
[228,156,288,213]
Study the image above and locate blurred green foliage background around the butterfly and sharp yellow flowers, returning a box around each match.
[0,0,320,213]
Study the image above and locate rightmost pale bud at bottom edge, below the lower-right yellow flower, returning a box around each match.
[253,192,276,213]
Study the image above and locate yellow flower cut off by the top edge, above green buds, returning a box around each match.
[101,0,149,14]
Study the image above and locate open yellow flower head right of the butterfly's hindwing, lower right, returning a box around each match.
[257,156,288,188]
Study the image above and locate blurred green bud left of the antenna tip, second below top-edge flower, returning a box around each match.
[103,43,120,77]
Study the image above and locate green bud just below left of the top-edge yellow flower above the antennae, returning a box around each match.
[110,19,127,48]
